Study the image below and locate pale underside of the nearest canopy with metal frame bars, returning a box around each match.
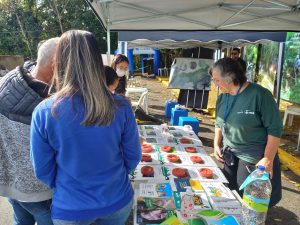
[86,0,300,31]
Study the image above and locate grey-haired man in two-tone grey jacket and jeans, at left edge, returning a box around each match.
[0,38,59,225]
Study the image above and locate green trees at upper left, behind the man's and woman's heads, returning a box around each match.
[0,0,117,58]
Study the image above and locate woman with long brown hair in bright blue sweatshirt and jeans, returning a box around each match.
[31,30,141,225]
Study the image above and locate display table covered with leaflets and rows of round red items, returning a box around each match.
[129,125,241,225]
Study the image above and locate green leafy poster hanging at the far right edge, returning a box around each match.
[281,32,300,104]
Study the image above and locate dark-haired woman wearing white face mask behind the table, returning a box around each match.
[111,54,129,95]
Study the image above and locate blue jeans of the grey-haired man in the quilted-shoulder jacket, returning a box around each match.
[8,199,53,225]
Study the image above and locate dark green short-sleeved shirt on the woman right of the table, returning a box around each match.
[216,83,283,163]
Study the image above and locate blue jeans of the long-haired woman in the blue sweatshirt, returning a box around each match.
[53,200,133,225]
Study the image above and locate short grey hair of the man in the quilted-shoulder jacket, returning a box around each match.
[37,37,59,66]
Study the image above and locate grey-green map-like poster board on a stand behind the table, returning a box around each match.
[168,58,214,90]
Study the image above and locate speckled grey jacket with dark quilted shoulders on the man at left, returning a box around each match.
[0,67,52,202]
